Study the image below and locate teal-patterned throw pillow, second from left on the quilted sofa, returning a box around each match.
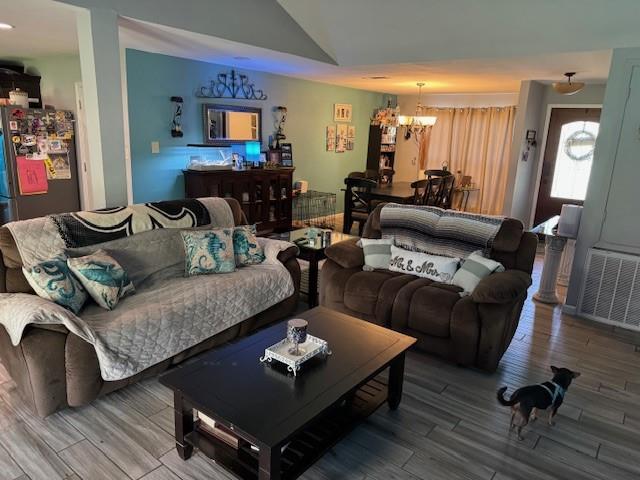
[67,250,135,310]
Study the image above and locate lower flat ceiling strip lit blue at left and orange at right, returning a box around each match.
[120,19,611,94]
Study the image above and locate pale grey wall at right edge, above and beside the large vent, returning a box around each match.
[566,48,640,307]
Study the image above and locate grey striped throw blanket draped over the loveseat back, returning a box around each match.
[380,203,504,258]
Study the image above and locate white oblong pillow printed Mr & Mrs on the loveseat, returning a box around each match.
[389,246,460,283]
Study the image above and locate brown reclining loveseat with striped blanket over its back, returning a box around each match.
[320,205,537,372]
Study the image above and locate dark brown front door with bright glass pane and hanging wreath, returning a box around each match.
[534,108,600,225]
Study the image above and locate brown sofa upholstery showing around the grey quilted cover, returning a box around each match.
[0,199,300,417]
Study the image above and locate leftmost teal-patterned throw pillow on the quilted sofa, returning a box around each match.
[22,257,89,313]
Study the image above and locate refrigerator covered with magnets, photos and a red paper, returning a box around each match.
[0,106,80,225]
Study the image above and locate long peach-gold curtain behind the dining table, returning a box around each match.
[418,106,516,215]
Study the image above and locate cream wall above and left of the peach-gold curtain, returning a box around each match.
[394,93,518,182]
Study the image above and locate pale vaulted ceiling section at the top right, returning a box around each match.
[278,0,640,66]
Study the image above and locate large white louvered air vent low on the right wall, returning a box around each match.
[578,248,640,330]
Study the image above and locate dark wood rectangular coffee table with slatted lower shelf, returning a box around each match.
[160,307,415,480]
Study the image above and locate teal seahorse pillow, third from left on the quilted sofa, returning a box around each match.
[180,228,236,277]
